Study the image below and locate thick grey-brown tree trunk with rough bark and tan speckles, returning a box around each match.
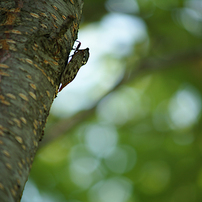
[0,0,83,202]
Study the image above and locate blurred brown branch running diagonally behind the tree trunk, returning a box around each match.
[40,49,202,148]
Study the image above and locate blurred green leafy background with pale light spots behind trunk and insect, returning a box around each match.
[22,0,202,202]
